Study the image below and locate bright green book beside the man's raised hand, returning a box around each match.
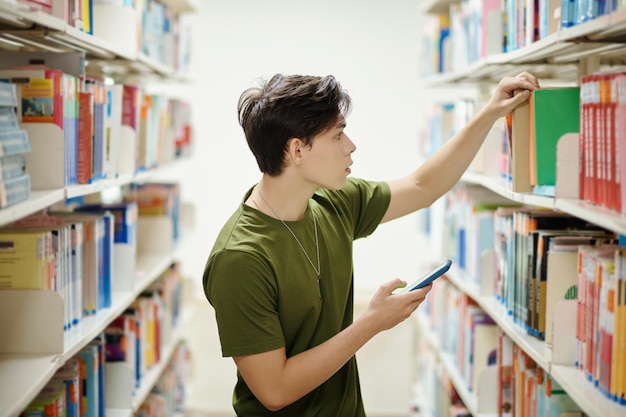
[530,87,580,195]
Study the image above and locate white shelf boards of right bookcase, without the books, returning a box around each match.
[414,1,626,417]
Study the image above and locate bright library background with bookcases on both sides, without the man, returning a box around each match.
[0,0,626,417]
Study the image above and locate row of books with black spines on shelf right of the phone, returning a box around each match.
[436,184,626,403]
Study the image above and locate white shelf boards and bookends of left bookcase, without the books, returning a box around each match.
[0,0,199,417]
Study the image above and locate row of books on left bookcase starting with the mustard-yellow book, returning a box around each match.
[0,183,180,331]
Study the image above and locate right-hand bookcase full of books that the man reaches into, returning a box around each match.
[414,1,626,417]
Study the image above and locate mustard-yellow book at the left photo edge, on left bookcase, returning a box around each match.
[0,230,54,290]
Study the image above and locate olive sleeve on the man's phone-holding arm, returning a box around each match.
[204,250,285,356]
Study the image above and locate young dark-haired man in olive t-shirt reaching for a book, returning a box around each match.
[203,73,538,417]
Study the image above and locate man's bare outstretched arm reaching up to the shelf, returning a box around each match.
[382,72,539,222]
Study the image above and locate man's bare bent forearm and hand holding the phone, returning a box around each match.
[233,279,432,411]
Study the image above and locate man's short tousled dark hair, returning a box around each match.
[238,74,351,176]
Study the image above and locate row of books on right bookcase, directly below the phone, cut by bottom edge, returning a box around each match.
[418,279,584,417]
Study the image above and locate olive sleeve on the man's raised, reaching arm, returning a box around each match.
[324,177,391,239]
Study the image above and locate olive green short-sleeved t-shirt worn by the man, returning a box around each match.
[203,178,390,417]
